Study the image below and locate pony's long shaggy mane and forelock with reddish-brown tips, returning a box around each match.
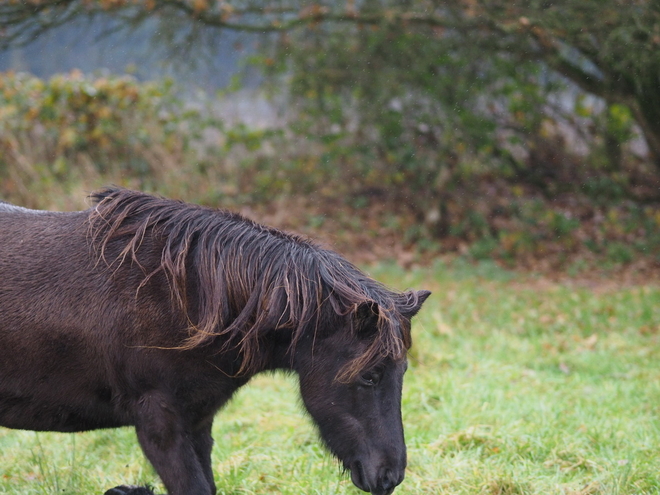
[89,188,417,380]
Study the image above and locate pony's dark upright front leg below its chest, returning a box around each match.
[135,392,215,495]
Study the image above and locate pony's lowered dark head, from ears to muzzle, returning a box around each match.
[295,291,430,495]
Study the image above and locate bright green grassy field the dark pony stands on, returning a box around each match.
[0,265,660,495]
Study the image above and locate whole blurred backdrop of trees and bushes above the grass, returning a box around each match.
[0,0,660,276]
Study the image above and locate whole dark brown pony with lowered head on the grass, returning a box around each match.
[0,189,430,495]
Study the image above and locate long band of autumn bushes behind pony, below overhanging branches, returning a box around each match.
[0,69,660,269]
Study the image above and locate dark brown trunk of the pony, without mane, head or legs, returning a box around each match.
[0,206,246,432]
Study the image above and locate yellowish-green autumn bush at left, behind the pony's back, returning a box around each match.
[0,71,219,202]
